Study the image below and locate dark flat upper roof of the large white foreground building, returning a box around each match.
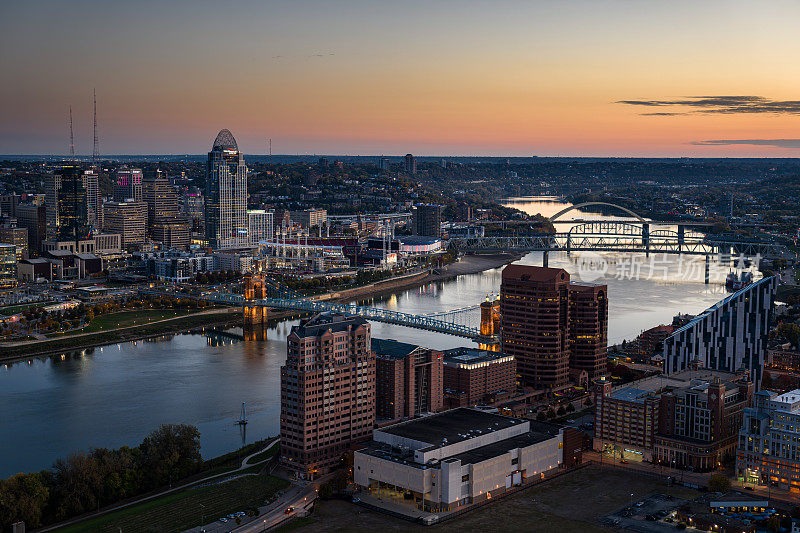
[376,407,527,446]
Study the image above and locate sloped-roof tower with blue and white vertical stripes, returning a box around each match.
[664,276,778,390]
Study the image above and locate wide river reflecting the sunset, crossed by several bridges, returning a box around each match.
[0,197,725,477]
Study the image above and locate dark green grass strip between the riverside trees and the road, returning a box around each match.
[59,475,288,533]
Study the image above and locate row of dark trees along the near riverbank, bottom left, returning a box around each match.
[0,424,203,528]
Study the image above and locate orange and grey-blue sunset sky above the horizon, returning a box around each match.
[0,0,800,157]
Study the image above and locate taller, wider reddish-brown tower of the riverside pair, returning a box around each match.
[500,264,570,389]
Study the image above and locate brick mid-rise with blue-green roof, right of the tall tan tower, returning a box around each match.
[372,339,442,420]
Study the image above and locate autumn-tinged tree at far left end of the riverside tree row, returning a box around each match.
[0,472,50,527]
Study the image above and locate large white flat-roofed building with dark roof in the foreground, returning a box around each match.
[353,407,563,511]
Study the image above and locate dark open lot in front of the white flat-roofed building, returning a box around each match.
[293,467,699,533]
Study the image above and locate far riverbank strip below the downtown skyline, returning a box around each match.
[0,254,522,362]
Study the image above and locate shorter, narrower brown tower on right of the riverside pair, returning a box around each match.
[569,282,608,379]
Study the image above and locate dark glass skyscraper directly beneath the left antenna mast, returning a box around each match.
[46,164,91,241]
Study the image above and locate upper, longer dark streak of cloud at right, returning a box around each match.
[616,96,800,116]
